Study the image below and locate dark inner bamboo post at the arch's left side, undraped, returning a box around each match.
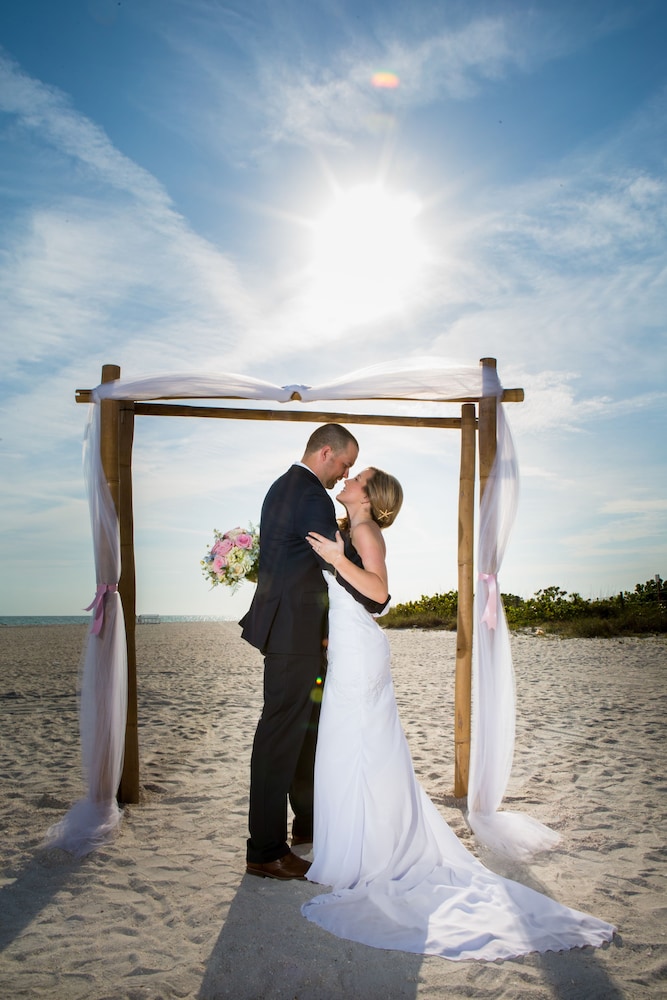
[118,401,139,802]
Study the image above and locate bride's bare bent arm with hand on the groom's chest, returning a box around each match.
[306,522,389,604]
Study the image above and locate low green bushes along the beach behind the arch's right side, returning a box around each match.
[380,576,667,638]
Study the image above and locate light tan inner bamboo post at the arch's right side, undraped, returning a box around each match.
[454,403,476,797]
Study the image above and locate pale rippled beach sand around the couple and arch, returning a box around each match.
[0,622,667,1000]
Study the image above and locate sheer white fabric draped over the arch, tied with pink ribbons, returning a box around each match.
[47,358,555,856]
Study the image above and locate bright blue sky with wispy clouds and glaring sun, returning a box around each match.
[0,0,667,618]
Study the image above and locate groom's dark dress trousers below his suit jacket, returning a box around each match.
[247,653,323,863]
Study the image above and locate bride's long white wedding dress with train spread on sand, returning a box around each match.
[302,573,614,961]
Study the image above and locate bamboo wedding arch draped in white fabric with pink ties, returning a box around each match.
[47,357,558,857]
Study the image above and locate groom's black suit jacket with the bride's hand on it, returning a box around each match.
[240,465,386,655]
